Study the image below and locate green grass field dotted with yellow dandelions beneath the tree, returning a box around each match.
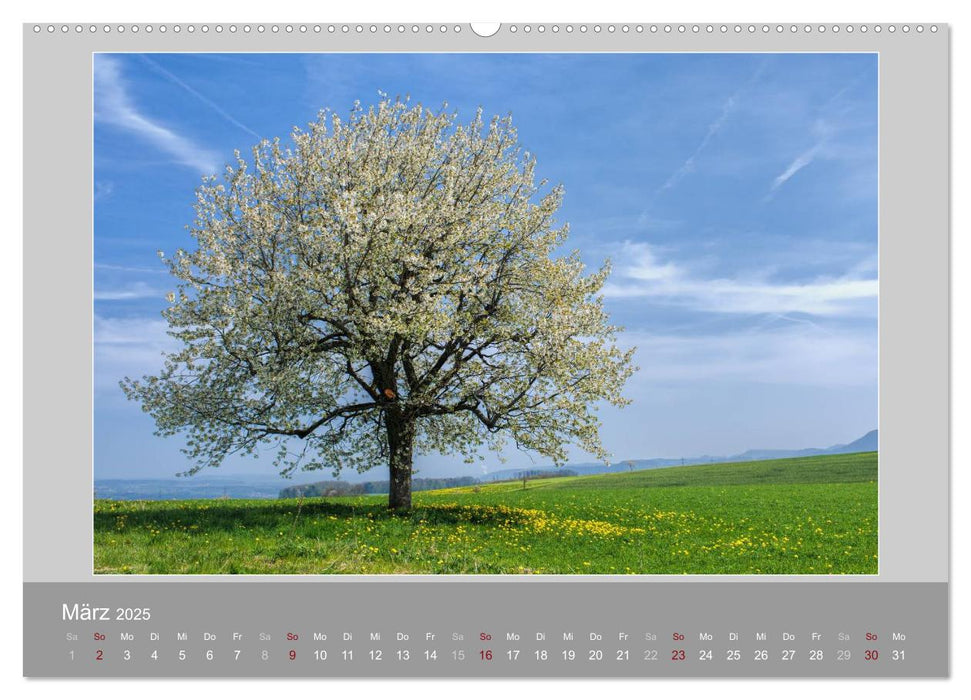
[94,452,877,574]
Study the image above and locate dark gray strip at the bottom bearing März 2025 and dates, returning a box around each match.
[23,580,949,678]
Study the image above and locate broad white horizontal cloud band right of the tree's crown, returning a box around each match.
[604,243,879,316]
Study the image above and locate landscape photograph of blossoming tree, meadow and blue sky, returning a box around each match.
[93,52,890,577]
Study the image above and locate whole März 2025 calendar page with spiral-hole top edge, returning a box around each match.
[23,23,950,678]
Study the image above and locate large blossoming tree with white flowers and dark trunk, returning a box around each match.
[122,99,634,510]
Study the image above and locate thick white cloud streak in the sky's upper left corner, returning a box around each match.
[94,54,220,174]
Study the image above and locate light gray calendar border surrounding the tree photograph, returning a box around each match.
[23,23,950,583]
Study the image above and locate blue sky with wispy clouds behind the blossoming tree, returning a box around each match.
[93,54,877,480]
